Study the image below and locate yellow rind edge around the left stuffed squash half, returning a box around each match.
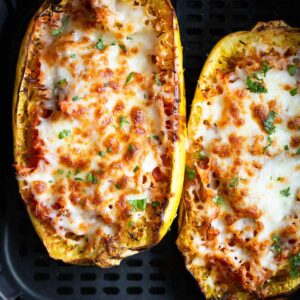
[13,0,186,267]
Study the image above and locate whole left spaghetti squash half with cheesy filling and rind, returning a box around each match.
[13,0,185,267]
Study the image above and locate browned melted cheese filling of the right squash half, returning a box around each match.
[177,43,300,297]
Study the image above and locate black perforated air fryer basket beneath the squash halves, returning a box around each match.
[0,0,300,300]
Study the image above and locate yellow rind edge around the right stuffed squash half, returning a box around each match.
[177,21,300,300]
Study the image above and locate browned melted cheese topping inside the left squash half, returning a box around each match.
[19,0,175,248]
